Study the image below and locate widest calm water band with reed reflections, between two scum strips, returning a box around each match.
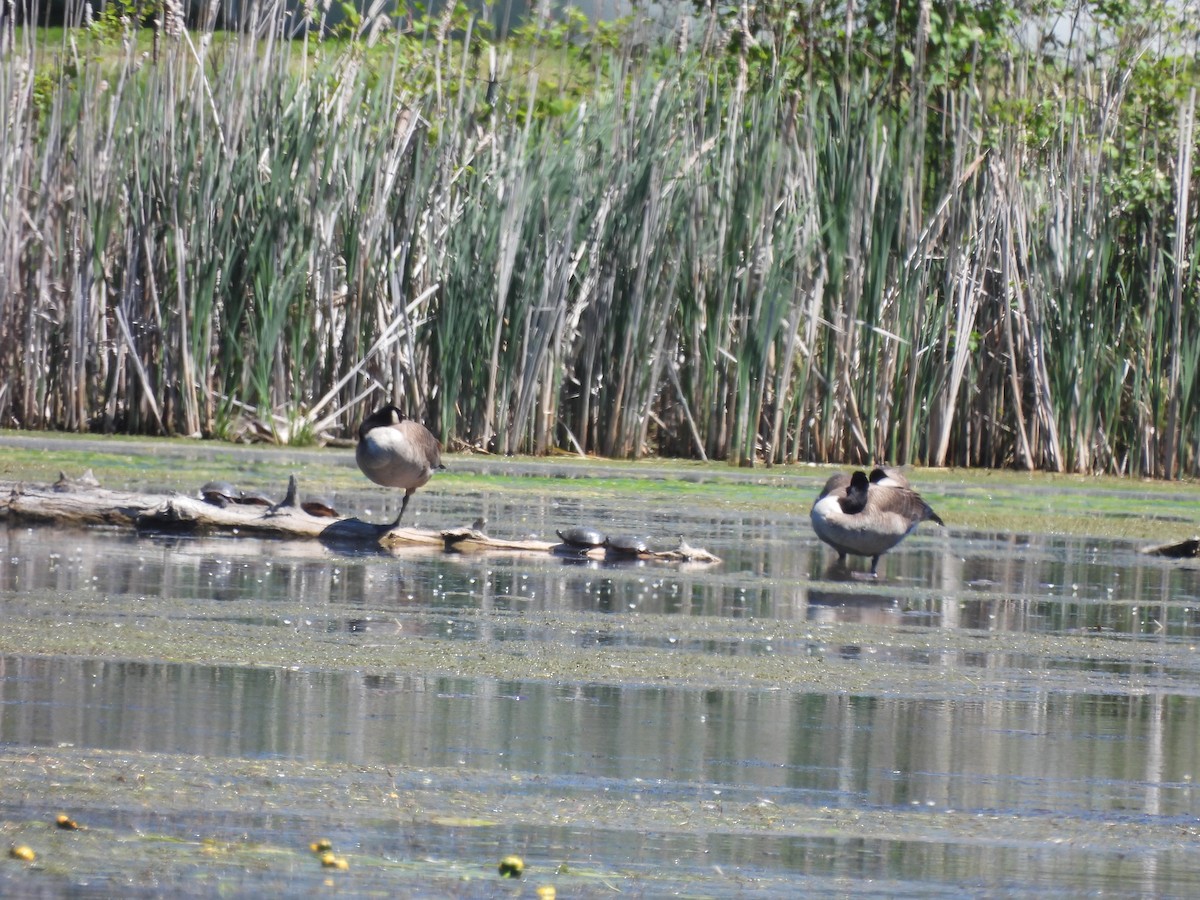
[7,656,1200,830]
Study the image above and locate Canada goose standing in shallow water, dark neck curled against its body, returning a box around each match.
[811,469,946,575]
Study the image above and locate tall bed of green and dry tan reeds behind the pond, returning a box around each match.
[0,1,1200,476]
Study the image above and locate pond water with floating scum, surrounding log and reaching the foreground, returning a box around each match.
[0,453,1200,896]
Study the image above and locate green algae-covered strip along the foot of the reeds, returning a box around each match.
[0,432,1200,544]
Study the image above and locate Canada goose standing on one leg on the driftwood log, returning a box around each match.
[354,406,445,528]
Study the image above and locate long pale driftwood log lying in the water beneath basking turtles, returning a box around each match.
[0,472,720,563]
